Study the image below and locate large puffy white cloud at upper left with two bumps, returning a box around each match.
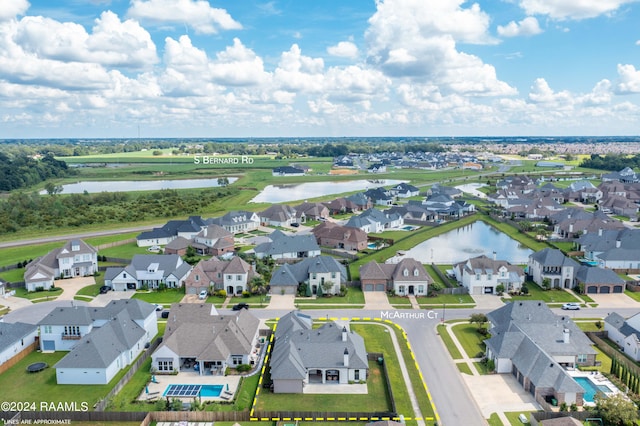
[14,12,158,68]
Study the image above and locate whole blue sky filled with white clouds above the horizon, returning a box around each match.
[0,0,640,138]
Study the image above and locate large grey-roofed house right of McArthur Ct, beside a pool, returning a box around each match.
[485,300,597,406]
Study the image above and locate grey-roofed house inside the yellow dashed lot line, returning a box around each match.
[270,311,369,393]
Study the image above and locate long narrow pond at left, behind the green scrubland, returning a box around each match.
[40,177,238,195]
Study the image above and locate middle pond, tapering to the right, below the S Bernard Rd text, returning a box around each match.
[250,179,407,203]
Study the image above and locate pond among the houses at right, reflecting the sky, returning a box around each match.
[406,221,533,265]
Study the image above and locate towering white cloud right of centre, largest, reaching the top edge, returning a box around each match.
[365,0,516,95]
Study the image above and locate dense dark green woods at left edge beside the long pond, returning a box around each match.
[0,152,73,191]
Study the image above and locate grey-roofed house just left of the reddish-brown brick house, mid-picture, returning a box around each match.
[254,230,320,259]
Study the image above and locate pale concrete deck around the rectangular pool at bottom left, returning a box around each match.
[138,372,241,402]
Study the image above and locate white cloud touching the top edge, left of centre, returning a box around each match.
[127,0,242,34]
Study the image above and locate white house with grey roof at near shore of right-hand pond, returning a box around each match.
[453,255,524,294]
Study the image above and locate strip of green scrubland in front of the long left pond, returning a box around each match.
[0,188,237,234]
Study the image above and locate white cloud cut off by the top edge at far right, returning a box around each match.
[520,0,636,20]
